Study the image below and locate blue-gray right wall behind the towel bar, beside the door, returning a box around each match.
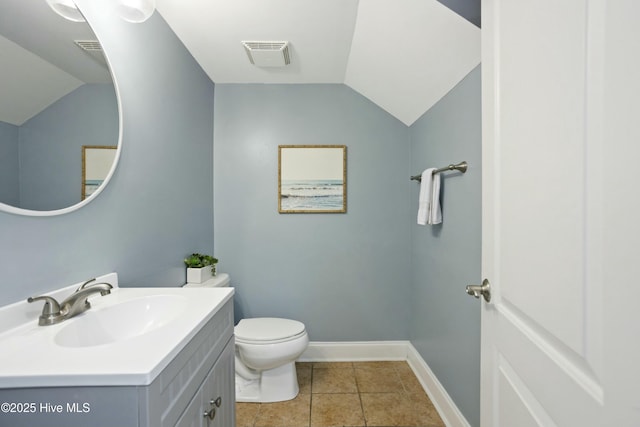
[409,66,482,426]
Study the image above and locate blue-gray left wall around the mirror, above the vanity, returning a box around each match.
[0,0,214,305]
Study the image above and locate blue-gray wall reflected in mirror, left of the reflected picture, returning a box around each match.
[18,84,118,210]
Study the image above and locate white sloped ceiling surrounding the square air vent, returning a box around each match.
[157,0,480,125]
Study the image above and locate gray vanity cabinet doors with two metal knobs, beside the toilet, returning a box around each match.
[176,338,236,427]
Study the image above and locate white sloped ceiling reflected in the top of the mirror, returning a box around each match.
[0,0,111,126]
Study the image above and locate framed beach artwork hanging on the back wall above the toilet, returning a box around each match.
[278,145,347,213]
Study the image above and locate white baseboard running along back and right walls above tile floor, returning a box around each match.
[298,341,470,427]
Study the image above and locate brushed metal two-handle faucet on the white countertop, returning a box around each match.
[27,279,113,326]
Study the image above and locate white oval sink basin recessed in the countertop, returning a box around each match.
[54,295,187,347]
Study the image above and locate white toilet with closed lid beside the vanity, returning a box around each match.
[185,273,309,402]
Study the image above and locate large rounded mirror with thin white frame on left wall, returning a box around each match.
[0,0,121,216]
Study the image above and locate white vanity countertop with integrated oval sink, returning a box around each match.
[0,273,233,388]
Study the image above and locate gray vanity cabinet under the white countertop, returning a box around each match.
[0,299,235,427]
